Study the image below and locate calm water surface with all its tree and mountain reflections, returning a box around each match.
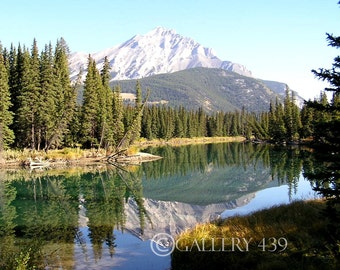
[0,143,316,269]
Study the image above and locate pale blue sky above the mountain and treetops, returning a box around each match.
[0,0,340,98]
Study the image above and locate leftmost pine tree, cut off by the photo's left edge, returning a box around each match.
[0,44,14,159]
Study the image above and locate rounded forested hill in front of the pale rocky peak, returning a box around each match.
[111,67,278,112]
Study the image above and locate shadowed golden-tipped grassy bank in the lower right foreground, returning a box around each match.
[172,200,339,270]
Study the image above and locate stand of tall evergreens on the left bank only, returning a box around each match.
[0,39,130,151]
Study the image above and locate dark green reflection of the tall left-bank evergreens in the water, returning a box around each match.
[0,167,147,270]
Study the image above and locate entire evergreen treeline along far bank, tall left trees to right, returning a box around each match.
[0,39,339,152]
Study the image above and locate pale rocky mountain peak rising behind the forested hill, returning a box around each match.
[69,27,251,80]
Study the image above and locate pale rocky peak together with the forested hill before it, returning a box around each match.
[69,27,302,111]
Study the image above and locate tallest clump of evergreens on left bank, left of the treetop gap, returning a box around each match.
[3,39,75,150]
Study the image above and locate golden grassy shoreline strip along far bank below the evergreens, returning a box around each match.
[0,136,245,169]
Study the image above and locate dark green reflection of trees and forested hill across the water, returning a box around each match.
[0,143,339,269]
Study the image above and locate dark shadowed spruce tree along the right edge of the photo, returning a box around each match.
[305,16,340,255]
